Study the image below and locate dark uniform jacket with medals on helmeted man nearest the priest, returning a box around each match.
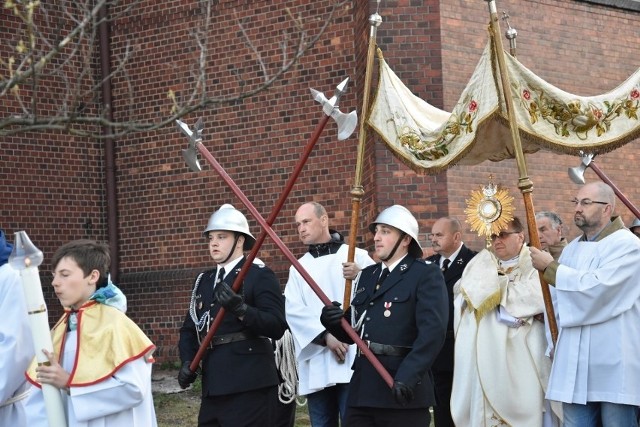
[340,256,448,409]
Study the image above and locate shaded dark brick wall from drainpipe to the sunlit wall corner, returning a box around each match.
[113,2,446,359]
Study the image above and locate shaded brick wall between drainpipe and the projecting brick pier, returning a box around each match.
[112,1,378,360]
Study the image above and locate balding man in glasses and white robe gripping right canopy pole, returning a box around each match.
[530,182,640,427]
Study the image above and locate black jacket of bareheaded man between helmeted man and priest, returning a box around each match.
[427,245,477,372]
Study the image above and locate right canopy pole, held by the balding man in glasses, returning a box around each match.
[485,0,558,345]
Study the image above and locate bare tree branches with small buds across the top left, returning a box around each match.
[0,0,350,138]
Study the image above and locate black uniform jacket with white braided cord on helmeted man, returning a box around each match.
[178,258,287,396]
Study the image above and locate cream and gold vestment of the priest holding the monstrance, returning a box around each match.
[451,246,557,427]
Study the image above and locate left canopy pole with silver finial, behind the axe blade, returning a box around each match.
[342,0,382,311]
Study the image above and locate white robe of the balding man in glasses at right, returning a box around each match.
[547,230,640,405]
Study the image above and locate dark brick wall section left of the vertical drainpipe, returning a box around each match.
[0,5,106,322]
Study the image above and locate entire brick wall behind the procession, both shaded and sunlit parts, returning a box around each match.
[0,0,640,362]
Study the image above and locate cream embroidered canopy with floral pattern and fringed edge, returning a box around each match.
[368,43,640,174]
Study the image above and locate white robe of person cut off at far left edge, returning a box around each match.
[0,264,34,427]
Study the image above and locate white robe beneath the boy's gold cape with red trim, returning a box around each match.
[26,326,158,427]
